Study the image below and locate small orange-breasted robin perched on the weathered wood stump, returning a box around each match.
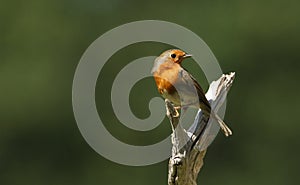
[151,49,232,136]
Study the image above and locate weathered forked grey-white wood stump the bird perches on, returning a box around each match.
[165,72,235,185]
